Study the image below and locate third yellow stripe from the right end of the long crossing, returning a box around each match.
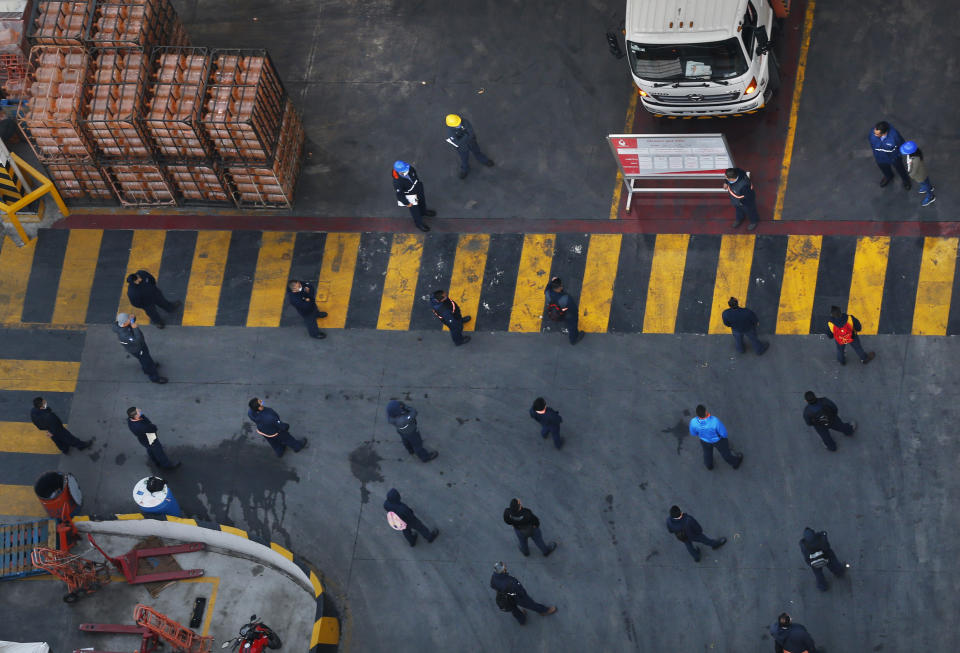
[777,236,823,335]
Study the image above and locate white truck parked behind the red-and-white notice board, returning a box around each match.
[624,0,780,118]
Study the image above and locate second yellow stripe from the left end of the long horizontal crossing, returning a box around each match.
[51,229,103,324]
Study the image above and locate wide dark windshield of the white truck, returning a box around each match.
[627,38,747,82]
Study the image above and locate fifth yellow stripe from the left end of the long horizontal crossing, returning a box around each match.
[247,231,297,327]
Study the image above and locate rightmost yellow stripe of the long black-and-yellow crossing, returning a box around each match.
[911,237,958,336]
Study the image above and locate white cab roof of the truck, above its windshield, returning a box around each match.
[626,0,752,44]
